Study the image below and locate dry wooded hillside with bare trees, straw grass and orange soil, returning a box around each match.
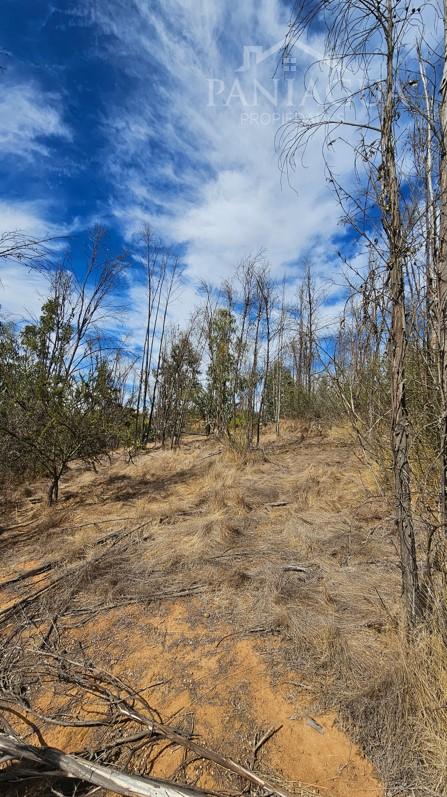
[0,0,447,797]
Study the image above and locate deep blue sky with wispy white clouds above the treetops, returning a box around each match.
[0,0,364,343]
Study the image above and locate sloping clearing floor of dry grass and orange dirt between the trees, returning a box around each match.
[0,428,399,797]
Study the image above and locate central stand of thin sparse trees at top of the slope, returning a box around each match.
[131,238,336,450]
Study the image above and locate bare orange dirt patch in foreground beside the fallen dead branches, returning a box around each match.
[88,601,383,797]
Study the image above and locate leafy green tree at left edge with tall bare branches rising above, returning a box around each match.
[0,229,125,503]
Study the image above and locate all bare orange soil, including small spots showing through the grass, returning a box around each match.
[0,426,384,797]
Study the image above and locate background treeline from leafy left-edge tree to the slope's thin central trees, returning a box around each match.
[0,229,333,503]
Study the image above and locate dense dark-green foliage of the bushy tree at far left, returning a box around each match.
[0,297,128,502]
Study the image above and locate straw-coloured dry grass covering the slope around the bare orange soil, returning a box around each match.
[0,428,447,797]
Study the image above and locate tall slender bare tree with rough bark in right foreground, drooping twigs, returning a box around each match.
[280,0,426,624]
